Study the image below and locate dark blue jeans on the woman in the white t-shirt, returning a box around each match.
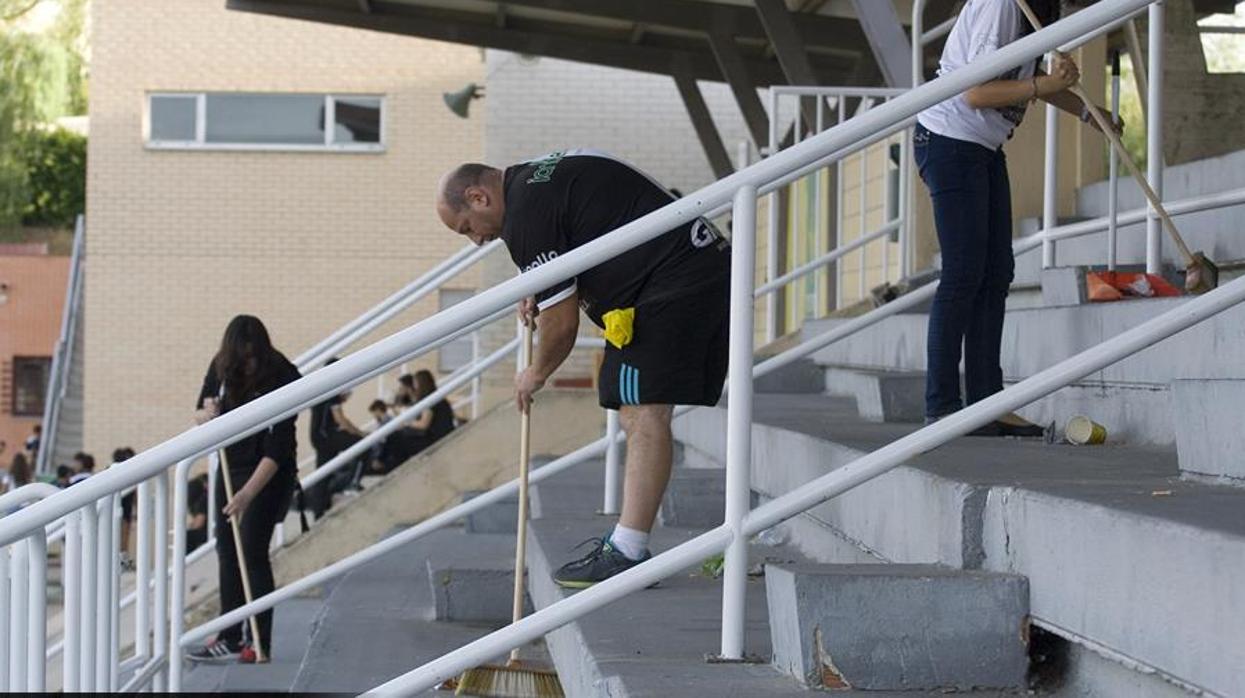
[913,124,1016,418]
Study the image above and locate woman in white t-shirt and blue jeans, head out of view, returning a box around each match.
[914,0,1110,437]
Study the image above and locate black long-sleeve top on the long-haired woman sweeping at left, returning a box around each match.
[195,356,301,477]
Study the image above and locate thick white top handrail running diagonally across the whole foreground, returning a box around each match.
[0,0,1165,691]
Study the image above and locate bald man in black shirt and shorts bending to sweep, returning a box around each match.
[437,149,731,589]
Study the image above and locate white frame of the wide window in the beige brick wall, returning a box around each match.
[143,91,388,153]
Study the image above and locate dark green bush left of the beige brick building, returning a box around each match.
[20,123,86,225]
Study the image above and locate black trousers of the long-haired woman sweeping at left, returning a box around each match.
[217,472,294,653]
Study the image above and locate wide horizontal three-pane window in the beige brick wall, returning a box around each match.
[147,92,385,152]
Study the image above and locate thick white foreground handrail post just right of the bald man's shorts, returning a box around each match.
[721,184,757,659]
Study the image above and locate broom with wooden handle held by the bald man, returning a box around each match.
[454,322,564,698]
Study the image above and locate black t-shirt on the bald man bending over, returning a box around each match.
[502,149,731,327]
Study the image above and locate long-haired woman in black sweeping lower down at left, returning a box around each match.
[190,315,299,662]
